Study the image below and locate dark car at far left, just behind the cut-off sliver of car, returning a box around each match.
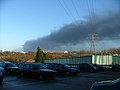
[0,61,20,74]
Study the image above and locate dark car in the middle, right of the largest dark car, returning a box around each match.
[47,63,79,76]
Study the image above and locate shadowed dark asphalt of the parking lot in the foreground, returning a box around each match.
[0,71,120,90]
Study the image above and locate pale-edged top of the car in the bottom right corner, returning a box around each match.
[90,78,120,90]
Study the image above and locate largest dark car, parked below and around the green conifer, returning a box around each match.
[21,63,57,80]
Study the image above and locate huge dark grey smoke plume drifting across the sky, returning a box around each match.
[23,13,120,51]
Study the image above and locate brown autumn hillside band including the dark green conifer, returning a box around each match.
[0,47,120,62]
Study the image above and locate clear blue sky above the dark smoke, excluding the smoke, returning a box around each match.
[0,0,119,51]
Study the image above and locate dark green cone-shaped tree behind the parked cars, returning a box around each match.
[35,47,44,63]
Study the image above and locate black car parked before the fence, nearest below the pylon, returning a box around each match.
[78,63,99,72]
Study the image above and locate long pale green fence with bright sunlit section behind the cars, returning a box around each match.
[45,55,120,67]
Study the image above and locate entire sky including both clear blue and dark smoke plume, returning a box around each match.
[0,0,120,51]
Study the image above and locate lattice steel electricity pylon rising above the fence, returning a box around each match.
[88,34,97,54]
